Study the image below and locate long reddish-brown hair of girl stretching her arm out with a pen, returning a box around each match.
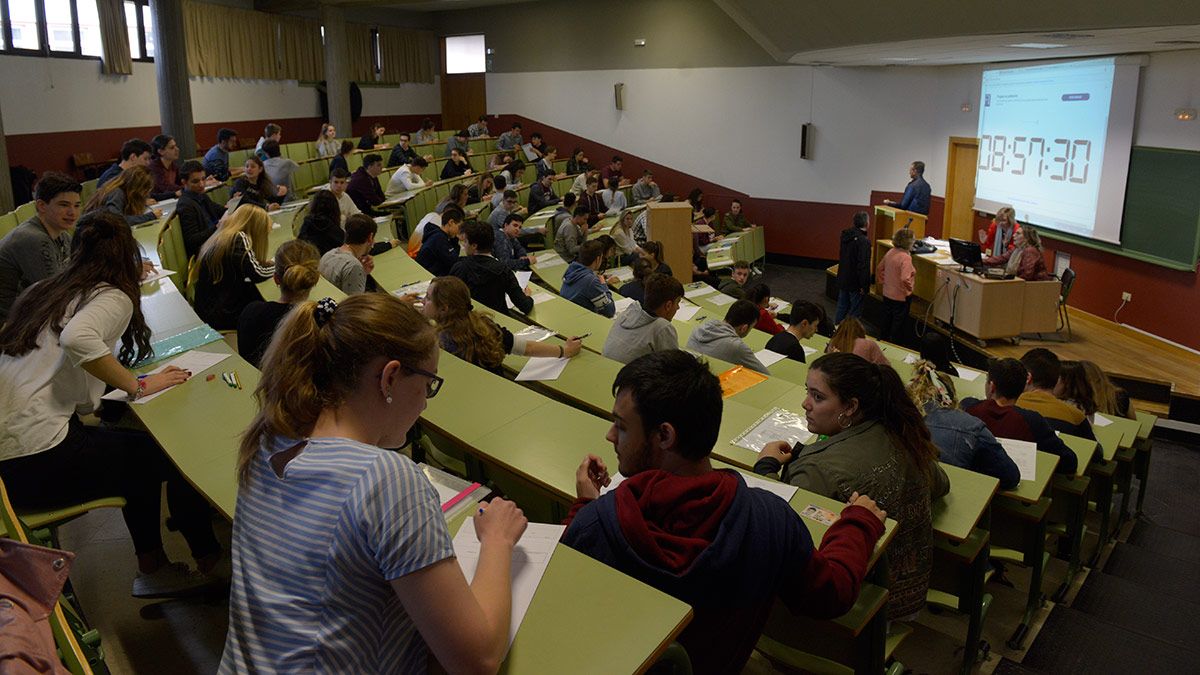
[426,276,504,369]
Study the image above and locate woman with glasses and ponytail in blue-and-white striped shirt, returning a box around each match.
[220,293,527,673]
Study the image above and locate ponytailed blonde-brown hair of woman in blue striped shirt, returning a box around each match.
[238,293,437,485]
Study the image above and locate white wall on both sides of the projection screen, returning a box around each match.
[487,50,1200,204]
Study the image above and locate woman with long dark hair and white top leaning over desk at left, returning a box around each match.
[0,211,221,595]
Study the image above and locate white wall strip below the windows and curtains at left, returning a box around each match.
[0,55,442,138]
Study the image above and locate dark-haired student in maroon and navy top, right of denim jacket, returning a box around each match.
[961,359,1079,474]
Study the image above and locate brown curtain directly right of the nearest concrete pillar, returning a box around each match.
[184,0,278,79]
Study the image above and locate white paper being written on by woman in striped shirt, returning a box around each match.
[454,522,566,645]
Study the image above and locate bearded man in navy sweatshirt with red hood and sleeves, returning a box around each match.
[563,350,887,673]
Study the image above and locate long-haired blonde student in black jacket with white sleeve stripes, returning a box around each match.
[192,203,275,330]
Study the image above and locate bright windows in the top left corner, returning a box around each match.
[0,0,155,61]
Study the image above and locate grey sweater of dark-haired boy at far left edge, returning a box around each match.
[0,216,71,324]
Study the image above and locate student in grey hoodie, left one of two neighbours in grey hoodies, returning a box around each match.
[601,274,683,363]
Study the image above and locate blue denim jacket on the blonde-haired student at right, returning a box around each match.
[925,404,1021,490]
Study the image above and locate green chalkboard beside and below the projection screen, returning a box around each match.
[1043,147,1200,270]
